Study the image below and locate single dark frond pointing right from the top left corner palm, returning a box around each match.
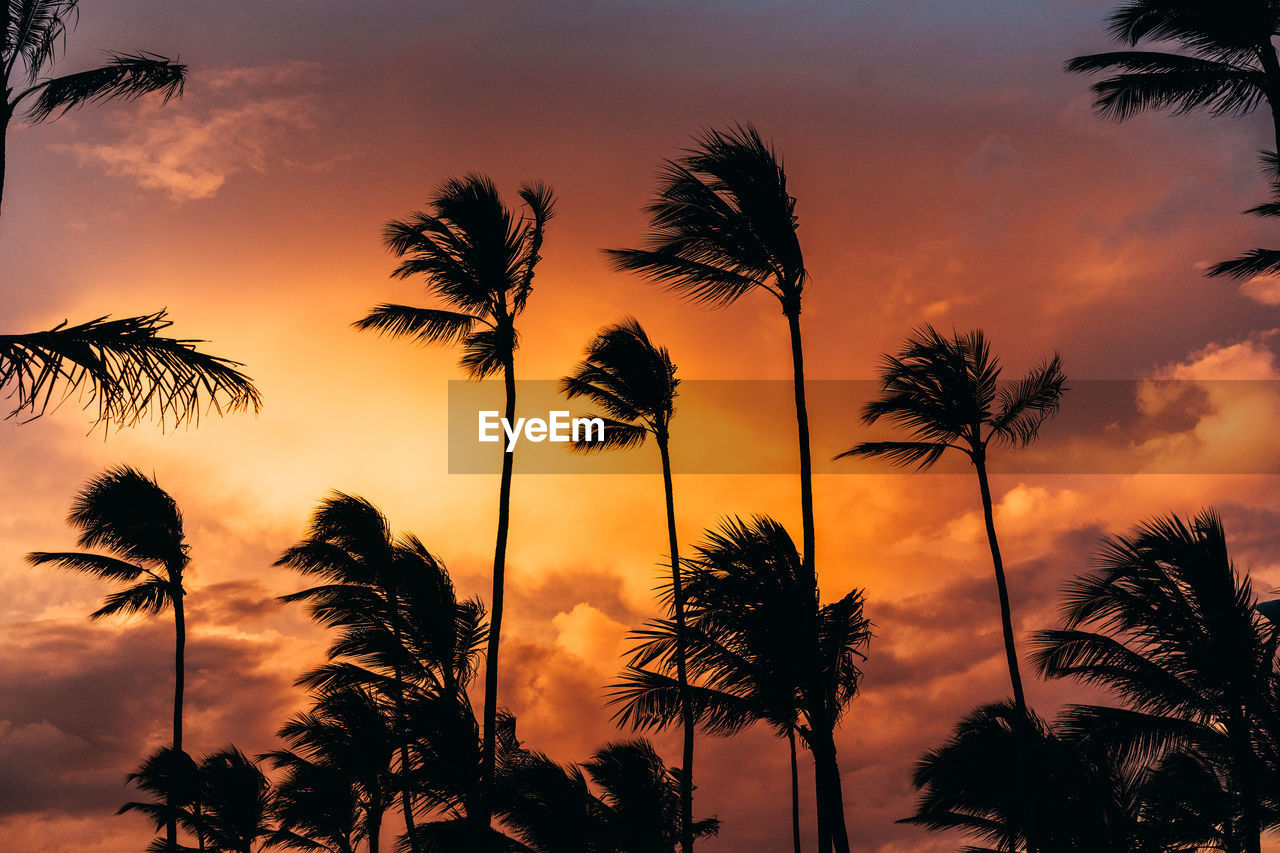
[14,51,187,123]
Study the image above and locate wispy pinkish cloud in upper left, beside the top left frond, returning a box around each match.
[54,61,332,201]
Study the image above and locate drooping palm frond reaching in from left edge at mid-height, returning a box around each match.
[0,311,262,427]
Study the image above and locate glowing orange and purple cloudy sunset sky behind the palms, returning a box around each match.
[0,0,1280,853]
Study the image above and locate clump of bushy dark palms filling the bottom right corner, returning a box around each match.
[908,511,1280,853]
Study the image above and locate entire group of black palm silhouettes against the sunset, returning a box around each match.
[20,0,1280,853]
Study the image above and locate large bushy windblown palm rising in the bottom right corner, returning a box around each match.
[1034,511,1280,853]
